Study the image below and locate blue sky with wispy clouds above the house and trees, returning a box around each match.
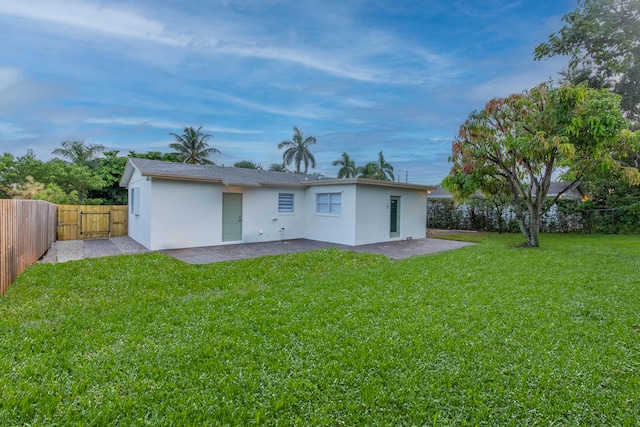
[0,0,577,184]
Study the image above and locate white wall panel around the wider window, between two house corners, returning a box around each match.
[305,184,356,246]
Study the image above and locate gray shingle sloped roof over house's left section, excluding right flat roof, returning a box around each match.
[120,158,328,187]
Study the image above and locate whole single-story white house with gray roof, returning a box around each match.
[120,158,434,250]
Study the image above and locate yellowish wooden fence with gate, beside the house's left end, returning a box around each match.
[58,205,129,240]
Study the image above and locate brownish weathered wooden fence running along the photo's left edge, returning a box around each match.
[0,200,58,295]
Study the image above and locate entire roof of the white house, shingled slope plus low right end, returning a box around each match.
[120,157,433,191]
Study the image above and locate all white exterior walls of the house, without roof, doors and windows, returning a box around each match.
[128,170,426,250]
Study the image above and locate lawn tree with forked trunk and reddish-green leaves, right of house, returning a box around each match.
[443,83,640,247]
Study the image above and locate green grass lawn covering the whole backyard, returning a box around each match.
[0,234,640,426]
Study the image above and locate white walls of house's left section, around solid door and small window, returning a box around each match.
[129,178,306,250]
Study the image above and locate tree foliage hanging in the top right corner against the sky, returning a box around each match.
[534,0,640,121]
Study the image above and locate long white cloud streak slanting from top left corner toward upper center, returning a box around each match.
[0,0,445,84]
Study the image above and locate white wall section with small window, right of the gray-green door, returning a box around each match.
[242,187,306,243]
